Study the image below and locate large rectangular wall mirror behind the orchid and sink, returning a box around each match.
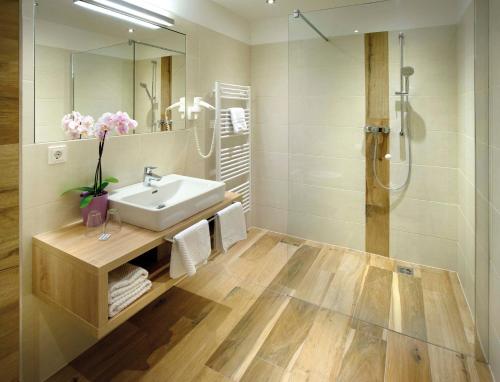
[34,0,186,143]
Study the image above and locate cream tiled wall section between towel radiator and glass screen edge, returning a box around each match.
[251,43,288,232]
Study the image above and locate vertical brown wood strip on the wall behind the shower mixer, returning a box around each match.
[365,32,390,256]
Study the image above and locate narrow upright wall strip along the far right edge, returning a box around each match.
[489,0,500,381]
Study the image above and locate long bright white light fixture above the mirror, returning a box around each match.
[73,0,175,29]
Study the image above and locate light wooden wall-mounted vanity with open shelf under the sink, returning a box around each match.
[33,192,241,338]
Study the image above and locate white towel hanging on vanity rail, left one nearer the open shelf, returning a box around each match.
[170,220,212,279]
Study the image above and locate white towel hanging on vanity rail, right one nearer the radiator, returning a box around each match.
[217,202,247,252]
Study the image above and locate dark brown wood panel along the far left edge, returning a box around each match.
[0,0,20,381]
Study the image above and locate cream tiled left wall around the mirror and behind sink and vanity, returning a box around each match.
[21,1,250,381]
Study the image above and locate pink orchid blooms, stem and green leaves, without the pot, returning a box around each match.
[62,111,137,208]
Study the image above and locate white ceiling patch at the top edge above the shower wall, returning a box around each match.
[212,0,386,21]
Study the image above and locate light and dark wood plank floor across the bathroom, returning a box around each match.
[50,230,491,382]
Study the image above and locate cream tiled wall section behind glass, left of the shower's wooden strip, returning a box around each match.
[288,35,365,249]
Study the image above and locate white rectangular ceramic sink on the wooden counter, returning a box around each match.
[109,175,226,231]
